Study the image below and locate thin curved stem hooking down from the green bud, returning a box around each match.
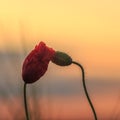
[72,61,97,120]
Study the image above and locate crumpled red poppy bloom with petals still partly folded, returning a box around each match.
[22,42,55,83]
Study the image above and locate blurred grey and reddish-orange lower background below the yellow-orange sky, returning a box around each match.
[0,52,120,120]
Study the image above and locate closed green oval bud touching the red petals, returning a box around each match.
[52,51,72,66]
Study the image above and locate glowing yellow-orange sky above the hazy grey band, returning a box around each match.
[0,0,120,80]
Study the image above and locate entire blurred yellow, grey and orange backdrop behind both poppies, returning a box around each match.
[0,0,120,120]
